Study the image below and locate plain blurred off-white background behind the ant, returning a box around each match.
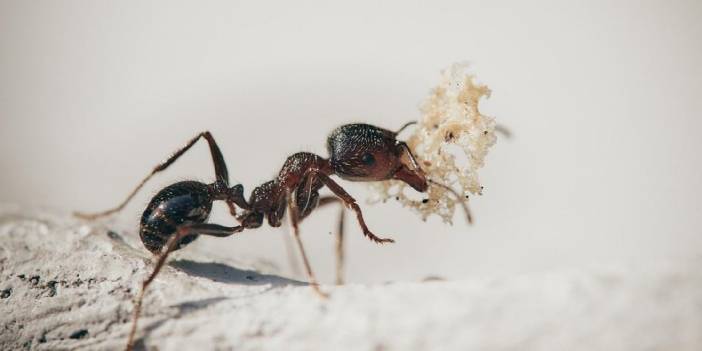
[0,0,702,282]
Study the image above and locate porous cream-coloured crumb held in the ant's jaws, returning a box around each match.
[370,63,497,223]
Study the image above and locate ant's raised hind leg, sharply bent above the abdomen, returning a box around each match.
[73,131,229,220]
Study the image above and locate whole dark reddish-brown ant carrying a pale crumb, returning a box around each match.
[76,122,470,350]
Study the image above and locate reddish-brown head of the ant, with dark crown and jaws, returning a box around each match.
[327,124,428,192]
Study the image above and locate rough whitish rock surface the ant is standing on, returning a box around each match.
[0,206,702,351]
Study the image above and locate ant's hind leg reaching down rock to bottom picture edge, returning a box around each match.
[126,223,244,351]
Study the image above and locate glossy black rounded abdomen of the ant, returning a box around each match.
[139,181,213,254]
